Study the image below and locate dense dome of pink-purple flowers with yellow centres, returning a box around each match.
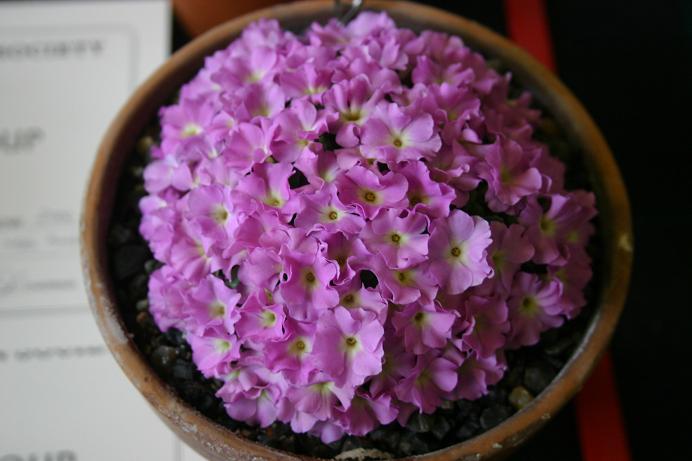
[140,13,595,442]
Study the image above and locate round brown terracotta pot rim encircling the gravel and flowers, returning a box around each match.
[81,1,632,461]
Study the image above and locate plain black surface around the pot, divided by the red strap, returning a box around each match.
[173,0,692,461]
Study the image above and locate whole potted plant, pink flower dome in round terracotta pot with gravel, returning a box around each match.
[82,2,631,460]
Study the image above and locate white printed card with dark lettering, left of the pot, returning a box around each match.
[0,0,201,461]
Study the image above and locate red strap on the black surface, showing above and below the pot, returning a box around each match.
[504,0,631,461]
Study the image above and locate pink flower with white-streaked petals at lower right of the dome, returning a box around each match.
[507,272,569,347]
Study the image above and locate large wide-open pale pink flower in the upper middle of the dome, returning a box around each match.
[361,103,442,162]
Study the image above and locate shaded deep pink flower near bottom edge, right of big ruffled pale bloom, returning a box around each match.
[394,352,457,413]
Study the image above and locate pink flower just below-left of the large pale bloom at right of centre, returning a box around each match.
[392,303,456,355]
